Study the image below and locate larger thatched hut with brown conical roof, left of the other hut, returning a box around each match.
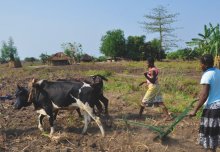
[48,52,75,66]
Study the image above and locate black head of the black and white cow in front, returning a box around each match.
[14,85,30,109]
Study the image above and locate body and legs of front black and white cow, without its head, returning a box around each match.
[15,79,105,136]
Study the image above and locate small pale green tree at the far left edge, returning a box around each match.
[1,37,19,61]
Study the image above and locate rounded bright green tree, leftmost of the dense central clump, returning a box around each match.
[100,29,125,58]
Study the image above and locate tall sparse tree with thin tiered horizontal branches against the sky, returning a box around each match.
[141,5,178,58]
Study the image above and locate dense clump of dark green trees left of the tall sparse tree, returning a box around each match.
[100,29,165,61]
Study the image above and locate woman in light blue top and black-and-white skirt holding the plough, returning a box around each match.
[189,54,220,152]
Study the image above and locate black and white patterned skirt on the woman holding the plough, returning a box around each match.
[199,102,220,149]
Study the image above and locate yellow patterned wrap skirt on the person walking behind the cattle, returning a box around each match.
[142,84,163,107]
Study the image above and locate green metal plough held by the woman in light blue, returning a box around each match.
[118,99,198,139]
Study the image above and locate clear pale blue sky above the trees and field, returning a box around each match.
[0,0,220,59]
